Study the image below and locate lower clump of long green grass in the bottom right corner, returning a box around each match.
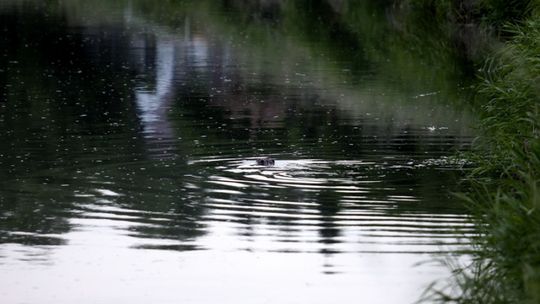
[423,141,540,304]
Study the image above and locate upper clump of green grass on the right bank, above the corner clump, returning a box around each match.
[475,17,540,174]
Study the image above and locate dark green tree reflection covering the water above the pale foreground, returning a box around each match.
[0,0,468,267]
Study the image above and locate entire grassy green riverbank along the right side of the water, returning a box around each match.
[402,1,540,303]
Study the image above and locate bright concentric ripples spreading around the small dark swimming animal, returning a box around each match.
[177,158,474,253]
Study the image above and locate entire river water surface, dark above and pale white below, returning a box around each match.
[0,0,474,303]
